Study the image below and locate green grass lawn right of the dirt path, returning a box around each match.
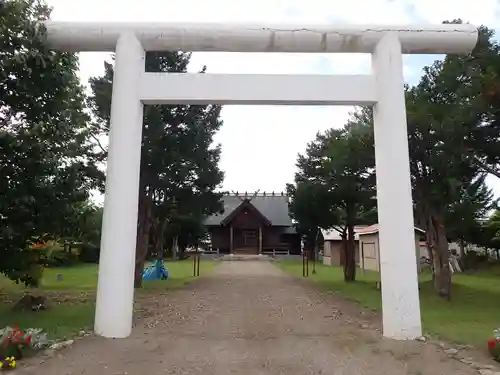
[277,261,500,347]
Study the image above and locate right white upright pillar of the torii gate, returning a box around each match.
[372,33,422,340]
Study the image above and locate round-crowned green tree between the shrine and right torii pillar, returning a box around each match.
[292,116,376,281]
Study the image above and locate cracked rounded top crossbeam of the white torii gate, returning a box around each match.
[45,21,478,54]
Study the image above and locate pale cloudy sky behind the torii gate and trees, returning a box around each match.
[48,0,500,201]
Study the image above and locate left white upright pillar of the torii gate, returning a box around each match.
[94,33,145,338]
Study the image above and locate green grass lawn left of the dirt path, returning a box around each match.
[0,260,217,338]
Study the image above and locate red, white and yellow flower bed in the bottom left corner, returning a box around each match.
[0,327,50,371]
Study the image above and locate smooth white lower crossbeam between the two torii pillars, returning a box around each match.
[140,73,377,105]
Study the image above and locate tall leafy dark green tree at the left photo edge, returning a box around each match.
[0,0,103,284]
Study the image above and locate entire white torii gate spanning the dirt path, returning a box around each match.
[45,22,478,339]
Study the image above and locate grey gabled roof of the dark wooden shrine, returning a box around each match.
[205,193,293,227]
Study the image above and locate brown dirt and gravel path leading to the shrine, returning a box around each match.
[15,261,496,375]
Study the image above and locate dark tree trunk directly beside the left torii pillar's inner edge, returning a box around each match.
[134,191,151,288]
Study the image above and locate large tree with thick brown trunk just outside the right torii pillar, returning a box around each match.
[407,23,498,299]
